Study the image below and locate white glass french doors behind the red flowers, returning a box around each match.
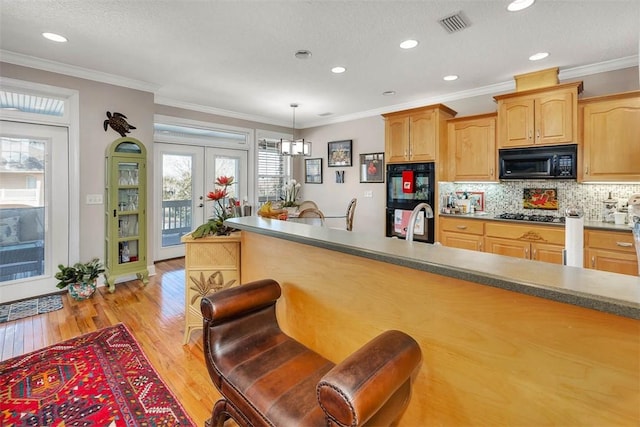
[152,143,248,261]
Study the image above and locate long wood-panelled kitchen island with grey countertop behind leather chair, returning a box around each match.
[227,217,640,426]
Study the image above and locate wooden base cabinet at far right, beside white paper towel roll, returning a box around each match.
[585,230,638,276]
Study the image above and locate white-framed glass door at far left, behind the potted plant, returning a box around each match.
[0,120,69,303]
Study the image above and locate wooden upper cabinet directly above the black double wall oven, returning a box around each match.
[383,104,456,168]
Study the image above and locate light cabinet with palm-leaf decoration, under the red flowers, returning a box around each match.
[182,232,241,344]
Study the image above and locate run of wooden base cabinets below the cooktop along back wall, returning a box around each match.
[438,215,638,276]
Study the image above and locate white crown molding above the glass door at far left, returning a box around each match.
[0,50,160,93]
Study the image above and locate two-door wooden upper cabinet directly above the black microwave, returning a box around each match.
[494,82,583,148]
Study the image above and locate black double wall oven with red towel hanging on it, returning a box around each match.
[386,163,436,243]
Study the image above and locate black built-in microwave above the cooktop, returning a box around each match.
[498,144,578,179]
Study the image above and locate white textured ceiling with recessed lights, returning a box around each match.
[0,0,640,128]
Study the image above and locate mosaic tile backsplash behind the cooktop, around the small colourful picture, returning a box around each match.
[439,180,640,221]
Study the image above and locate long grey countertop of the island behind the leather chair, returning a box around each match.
[225,216,640,319]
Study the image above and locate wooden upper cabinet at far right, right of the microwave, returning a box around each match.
[578,91,640,182]
